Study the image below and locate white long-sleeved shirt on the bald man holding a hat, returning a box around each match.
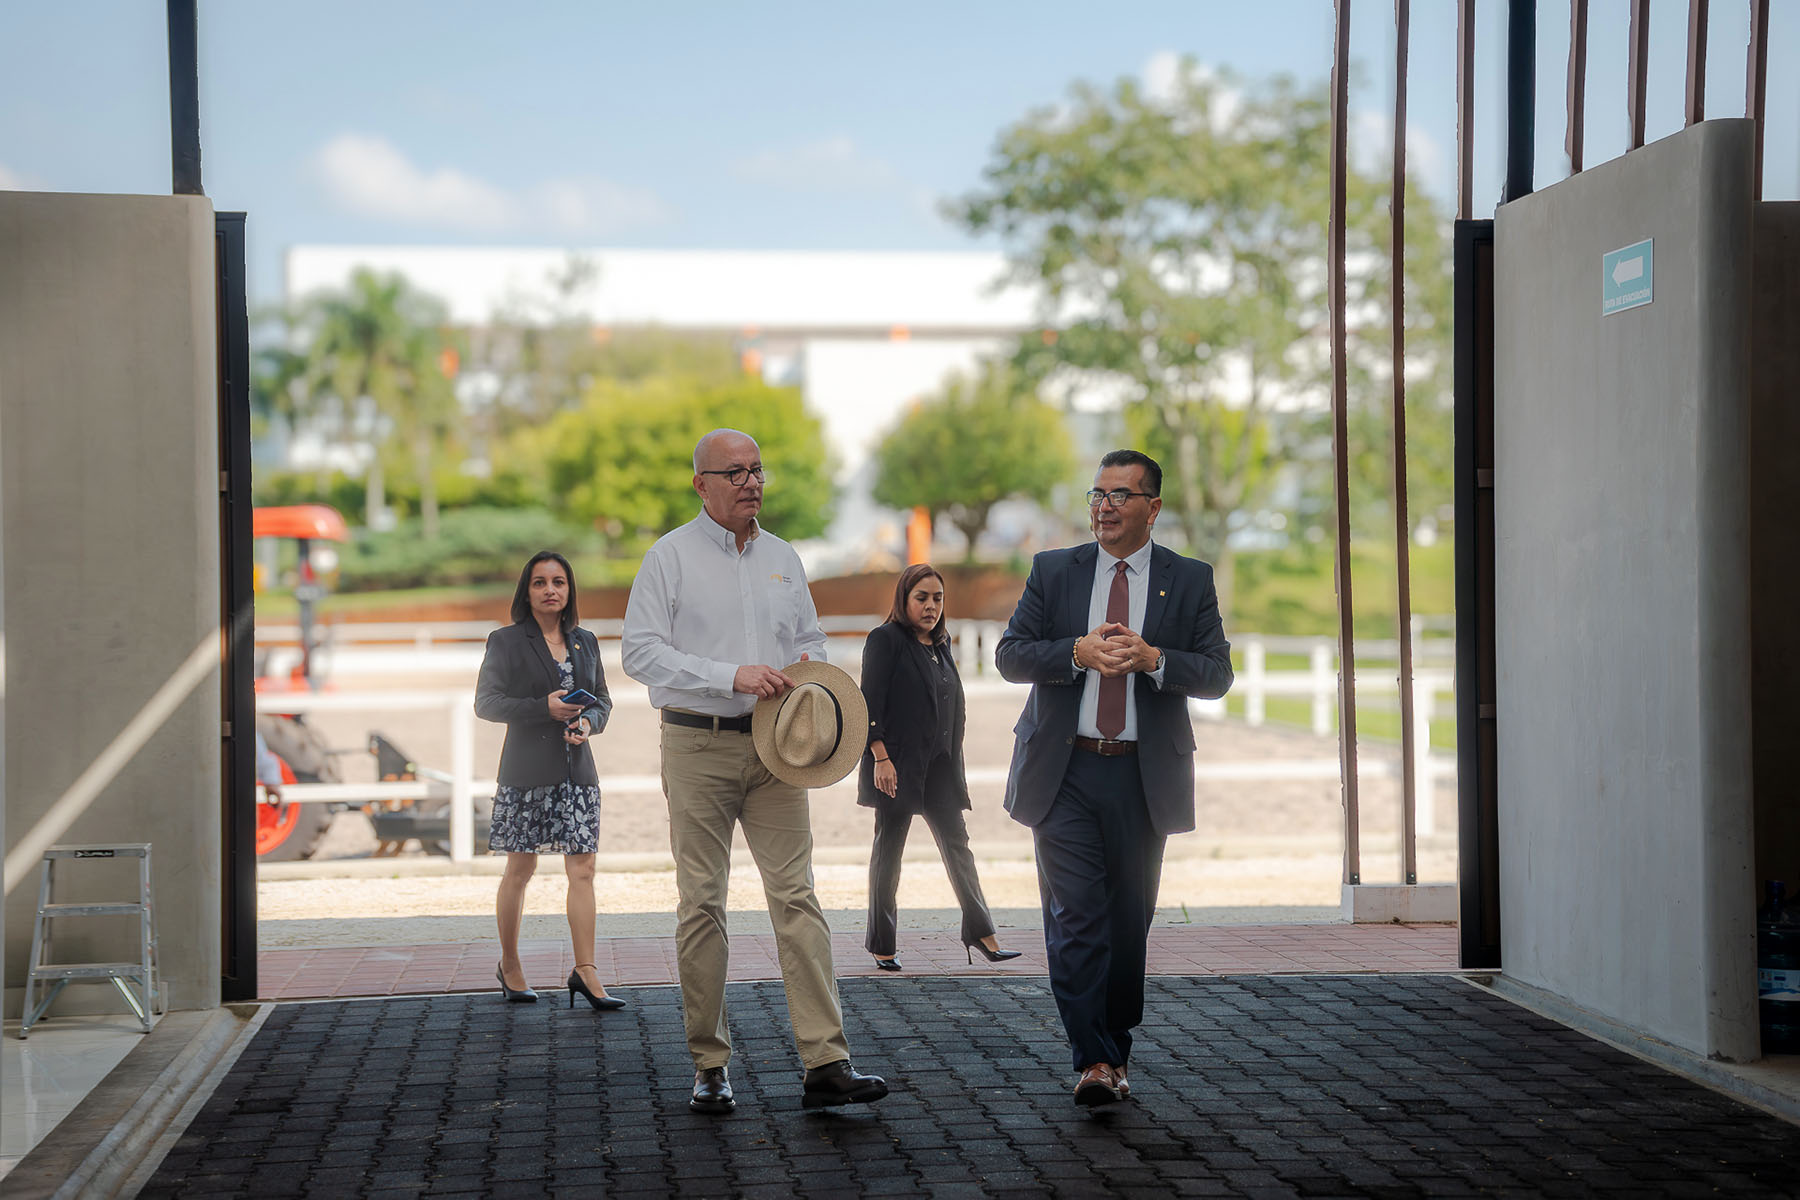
[619,509,824,716]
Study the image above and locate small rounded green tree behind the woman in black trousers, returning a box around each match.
[873,363,1075,561]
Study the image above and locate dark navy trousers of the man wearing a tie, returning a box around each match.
[1031,750,1166,1070]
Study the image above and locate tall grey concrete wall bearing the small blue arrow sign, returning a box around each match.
[1494,121,1759,1060]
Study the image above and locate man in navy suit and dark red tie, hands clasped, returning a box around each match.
[994,450,1231,1106]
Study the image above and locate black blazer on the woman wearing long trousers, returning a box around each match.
[857,621,968,813]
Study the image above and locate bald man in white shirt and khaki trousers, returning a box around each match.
[621,430,887,1114]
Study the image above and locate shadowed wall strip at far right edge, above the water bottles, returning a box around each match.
[1750,203,1800,896]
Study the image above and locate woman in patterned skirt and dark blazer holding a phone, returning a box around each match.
[475,551,625,1009]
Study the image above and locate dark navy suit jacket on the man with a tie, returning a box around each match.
[994,542,1231,833]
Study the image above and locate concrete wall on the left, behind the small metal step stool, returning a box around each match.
[0,193,221,1016]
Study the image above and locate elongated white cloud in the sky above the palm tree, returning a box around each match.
[311,133,670,236]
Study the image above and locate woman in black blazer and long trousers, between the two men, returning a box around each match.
[857,563,1019,972]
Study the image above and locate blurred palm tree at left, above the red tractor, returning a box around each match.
[302,270,461,538]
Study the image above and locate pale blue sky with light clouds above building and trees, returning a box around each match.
[0,0,1800,302]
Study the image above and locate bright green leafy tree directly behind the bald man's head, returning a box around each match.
[504,376,835,552]
